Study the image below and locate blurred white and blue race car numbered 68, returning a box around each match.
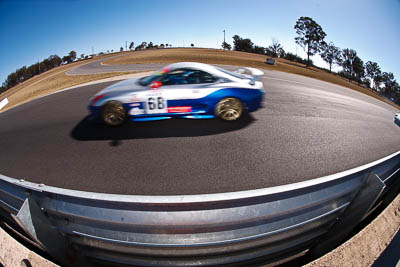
[89,62,265,126]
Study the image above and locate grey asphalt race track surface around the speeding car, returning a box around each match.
[0,61,400,195]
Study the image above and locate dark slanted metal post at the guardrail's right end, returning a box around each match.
[308,172,385,258]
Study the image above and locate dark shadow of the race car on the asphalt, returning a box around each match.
[71,114,255,142]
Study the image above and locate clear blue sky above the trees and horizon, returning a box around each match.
[0,0,400,82]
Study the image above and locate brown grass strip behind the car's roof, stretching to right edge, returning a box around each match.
[103,48,400,108]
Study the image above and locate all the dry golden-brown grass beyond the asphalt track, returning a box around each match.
[0,48,400,111]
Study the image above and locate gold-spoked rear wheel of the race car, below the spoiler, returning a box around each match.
[215,97,243,121]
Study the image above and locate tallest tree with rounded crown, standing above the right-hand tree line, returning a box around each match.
[294,17,326,67]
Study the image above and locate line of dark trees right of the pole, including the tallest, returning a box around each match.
[222,17,400,104]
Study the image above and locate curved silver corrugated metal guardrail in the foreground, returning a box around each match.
[0,152,400,266]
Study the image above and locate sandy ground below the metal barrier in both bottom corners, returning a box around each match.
[0,196,400,267]
